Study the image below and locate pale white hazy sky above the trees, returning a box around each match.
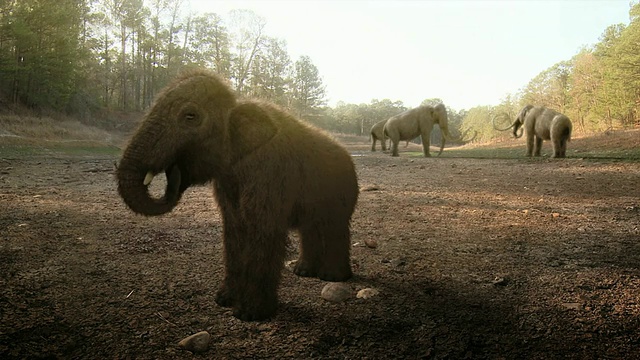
[190,0,630,110]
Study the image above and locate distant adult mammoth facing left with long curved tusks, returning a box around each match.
[493,105,573,158]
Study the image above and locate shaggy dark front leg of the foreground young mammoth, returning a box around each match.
[216,217,287,321]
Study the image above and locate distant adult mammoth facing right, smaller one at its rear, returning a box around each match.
[384,104,454,157]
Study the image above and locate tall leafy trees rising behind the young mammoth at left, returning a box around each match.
[0,0,327,120]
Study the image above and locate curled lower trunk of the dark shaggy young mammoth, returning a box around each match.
[117,151,181,216]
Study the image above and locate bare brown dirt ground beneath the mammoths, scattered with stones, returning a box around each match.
[0,134,640,359]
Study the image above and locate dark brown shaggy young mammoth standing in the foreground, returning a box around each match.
[117,71,358,320]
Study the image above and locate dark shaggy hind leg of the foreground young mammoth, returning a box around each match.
[294,219,352,281]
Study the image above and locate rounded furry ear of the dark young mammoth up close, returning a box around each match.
[229,103,278,161]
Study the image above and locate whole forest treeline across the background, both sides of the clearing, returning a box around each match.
[0,0,640,141]
